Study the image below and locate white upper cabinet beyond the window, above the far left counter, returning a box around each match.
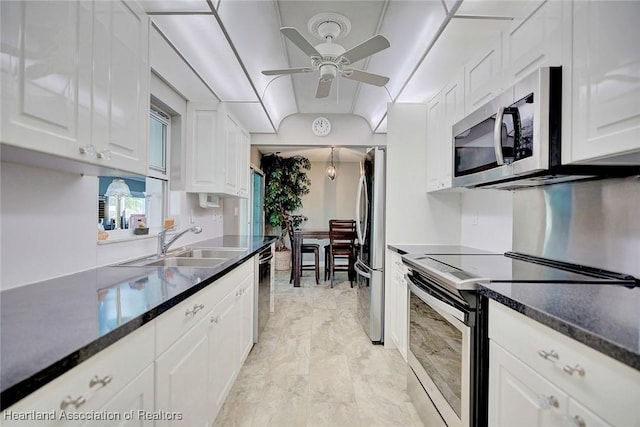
[185,102,250,198]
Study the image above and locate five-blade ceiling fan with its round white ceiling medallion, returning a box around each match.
[262,13,391,98]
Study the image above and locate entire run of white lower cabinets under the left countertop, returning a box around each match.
[0,258,255,427]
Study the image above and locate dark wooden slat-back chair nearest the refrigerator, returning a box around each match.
[325,219,356,287]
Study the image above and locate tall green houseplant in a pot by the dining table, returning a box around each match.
[261,154,311,269]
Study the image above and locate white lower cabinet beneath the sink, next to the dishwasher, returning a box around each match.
[156,259,254,427]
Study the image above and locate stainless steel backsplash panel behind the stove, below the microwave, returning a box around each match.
[513,177,640,277]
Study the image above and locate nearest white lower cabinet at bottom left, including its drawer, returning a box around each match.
[0,322,155,427]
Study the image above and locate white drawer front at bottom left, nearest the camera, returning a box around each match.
[0,322,154,427]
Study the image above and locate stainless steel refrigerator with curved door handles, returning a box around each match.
[355,148,385,343]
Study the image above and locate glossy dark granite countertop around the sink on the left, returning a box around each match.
[0,236,274,410]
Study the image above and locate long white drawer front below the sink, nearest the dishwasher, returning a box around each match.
[155,259,254,356]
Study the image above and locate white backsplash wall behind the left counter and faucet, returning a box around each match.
[0,162,223,289]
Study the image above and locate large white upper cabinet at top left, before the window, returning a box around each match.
[1,1,149,175]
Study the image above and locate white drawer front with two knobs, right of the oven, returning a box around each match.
[489,301,640,425]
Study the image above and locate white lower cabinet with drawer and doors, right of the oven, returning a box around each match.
[489,301,640,427]
